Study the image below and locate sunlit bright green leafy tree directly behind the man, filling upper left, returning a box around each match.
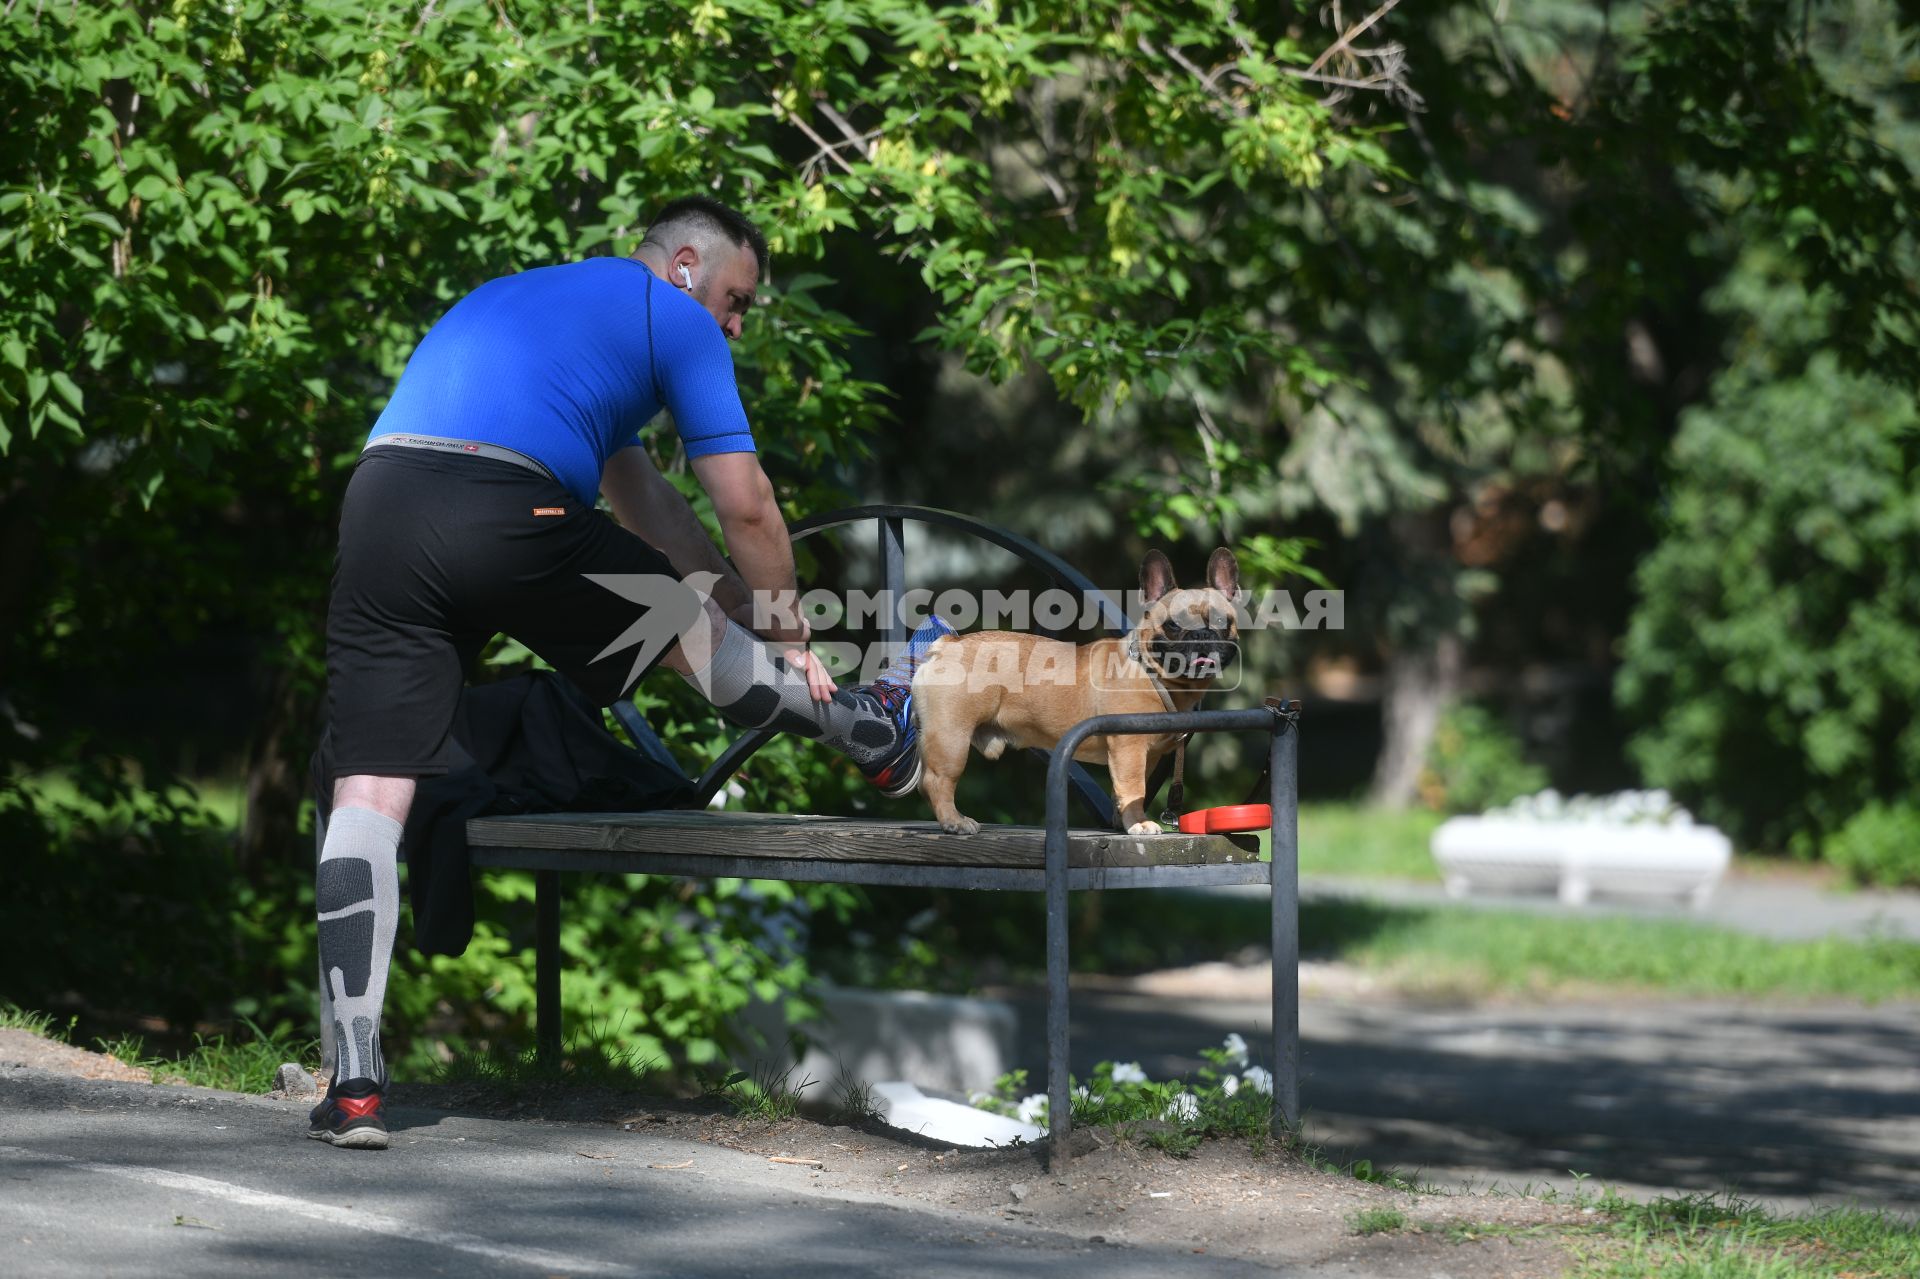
[0,0,1373,1058]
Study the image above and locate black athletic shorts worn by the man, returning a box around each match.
[326,447,680,778]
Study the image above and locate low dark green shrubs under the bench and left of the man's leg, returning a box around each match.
[0,768,852,1079]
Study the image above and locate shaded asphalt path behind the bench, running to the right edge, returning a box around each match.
[1014,991,1920,1214]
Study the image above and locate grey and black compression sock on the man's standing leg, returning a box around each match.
[315,808,401,1085]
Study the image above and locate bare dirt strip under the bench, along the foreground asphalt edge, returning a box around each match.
[0,1029,1590,1279]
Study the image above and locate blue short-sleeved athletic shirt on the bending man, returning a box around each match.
[367,257,755,505]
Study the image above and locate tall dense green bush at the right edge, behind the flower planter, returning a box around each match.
[1619,2,1920,856]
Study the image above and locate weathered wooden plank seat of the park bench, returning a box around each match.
[467,810,1260,868]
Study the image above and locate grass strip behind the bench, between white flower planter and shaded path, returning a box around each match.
[810,841,1920,1002]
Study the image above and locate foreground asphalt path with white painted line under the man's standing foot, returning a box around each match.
[0,1068,1279,1279]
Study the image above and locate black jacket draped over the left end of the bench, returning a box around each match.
[313,670,693,954]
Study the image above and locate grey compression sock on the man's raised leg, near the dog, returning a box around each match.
[687,622,899,764]
